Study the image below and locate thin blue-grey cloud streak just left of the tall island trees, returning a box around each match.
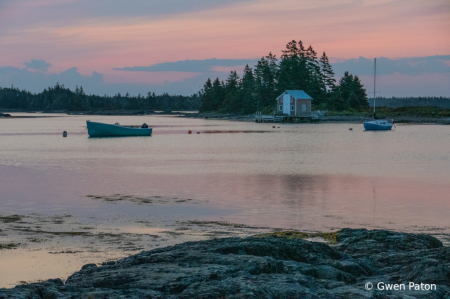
[113,58,258,73]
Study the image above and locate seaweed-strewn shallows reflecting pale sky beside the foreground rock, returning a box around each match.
[0,213,271,288]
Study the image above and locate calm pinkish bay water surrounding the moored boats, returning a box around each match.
[0,114,450,287]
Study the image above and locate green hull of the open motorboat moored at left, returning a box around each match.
[86,121,152,137]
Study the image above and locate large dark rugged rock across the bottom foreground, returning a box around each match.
[0,229,450,298]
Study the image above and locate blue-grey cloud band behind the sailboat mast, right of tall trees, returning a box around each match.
[332,55,450,76]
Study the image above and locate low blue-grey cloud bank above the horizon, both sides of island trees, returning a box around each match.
[0,55,450,97]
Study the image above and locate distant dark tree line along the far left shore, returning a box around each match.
[0,83,201,111]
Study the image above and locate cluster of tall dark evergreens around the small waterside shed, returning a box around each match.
[199,40,369,114]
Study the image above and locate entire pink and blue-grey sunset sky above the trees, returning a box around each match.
[0,0,450,97]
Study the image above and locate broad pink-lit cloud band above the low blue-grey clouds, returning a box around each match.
[0,0,450,89]
